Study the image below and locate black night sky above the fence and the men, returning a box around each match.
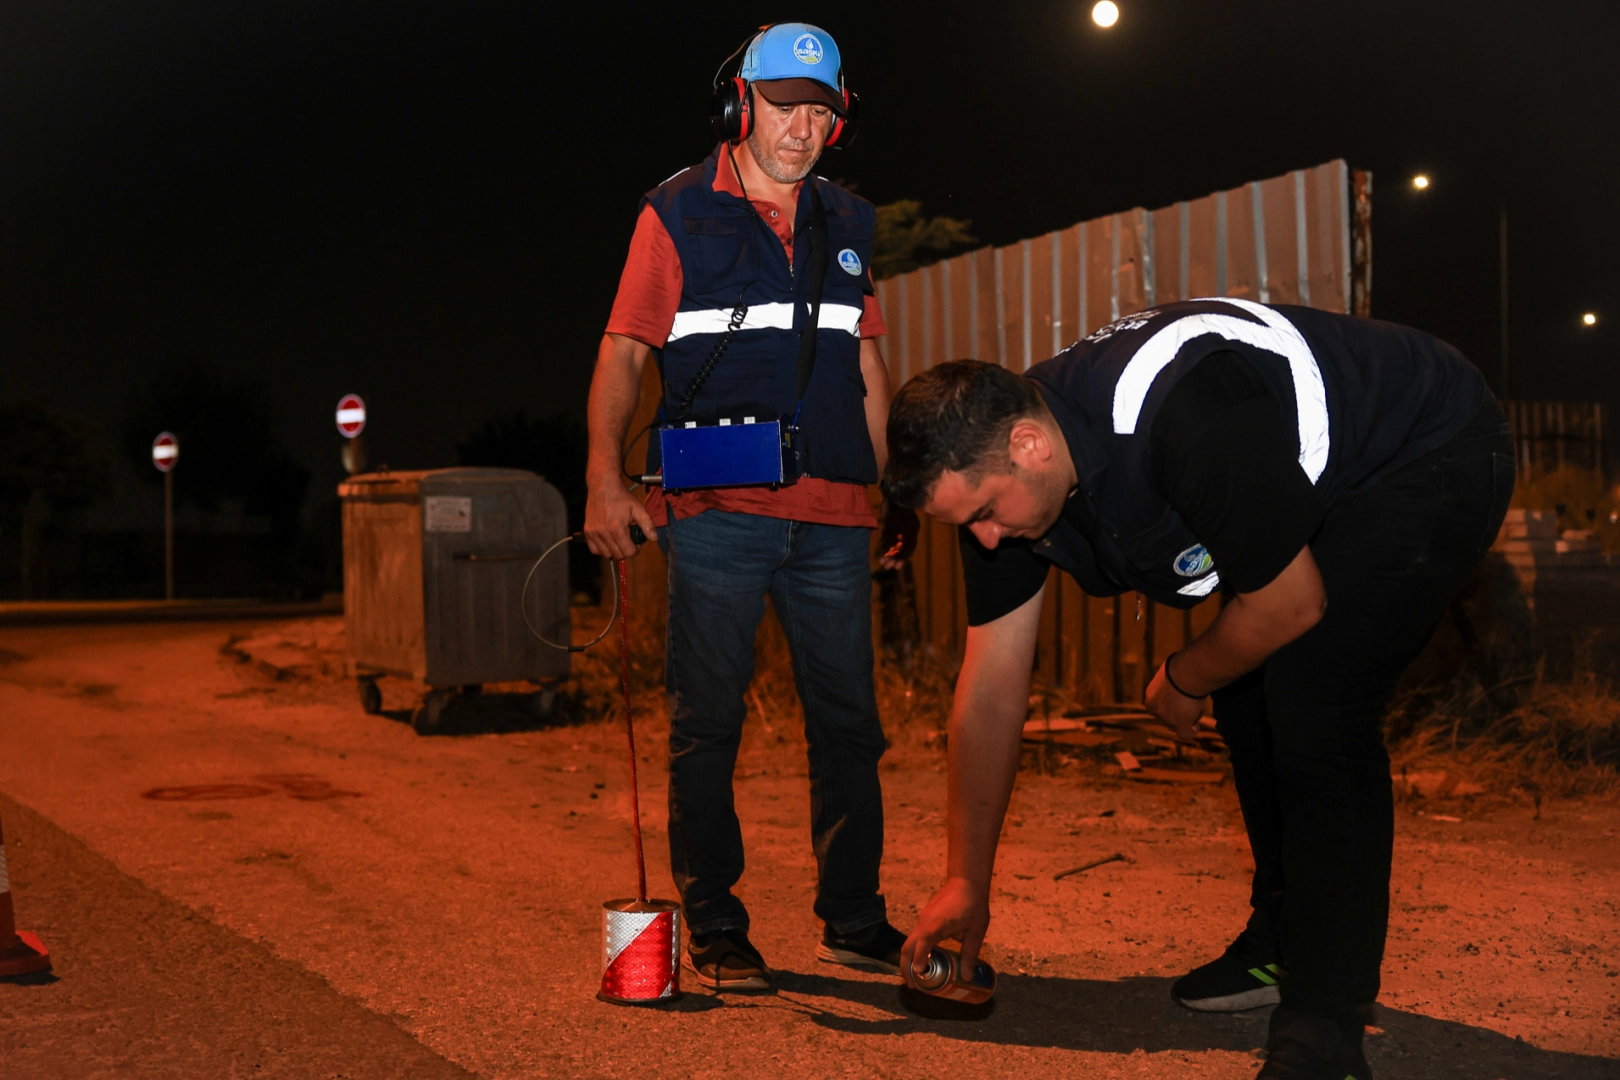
[0,0,1620,508]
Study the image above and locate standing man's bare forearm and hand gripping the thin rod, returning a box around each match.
[585,334,653,559]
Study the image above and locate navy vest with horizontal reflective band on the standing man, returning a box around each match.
[645,147,878,484]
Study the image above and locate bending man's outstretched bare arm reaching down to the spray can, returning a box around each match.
[901,593,1042,981]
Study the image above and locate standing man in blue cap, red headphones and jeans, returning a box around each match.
[585,23,915,989]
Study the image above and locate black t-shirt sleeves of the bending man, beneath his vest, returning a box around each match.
[959,353,1327,627]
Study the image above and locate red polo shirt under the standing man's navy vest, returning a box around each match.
[608,146,889,528]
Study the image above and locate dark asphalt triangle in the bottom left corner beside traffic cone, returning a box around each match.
[0,795,473,1080]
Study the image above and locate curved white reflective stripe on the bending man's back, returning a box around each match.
[1113,296,1330,482]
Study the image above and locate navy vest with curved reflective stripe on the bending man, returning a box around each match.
[1029,298,1489,607]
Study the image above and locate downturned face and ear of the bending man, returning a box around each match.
[923,421,1069,549]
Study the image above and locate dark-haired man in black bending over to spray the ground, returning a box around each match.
[885,300,1515,1080]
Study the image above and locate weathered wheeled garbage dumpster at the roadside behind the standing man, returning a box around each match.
[337,468,569,733]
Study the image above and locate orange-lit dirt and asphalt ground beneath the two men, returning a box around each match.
[0,619,1620,1080]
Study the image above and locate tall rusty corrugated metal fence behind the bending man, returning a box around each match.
[878,160,1360,701]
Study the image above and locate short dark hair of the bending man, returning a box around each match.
[883,359,1047,507]
